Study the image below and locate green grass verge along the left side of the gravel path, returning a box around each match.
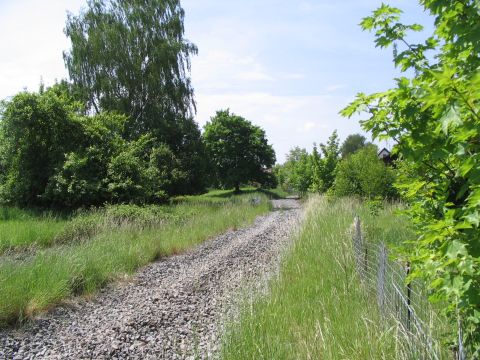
[0,193,271,326]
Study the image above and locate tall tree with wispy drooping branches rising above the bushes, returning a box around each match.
[64,0,197,137]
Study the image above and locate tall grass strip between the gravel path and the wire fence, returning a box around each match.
[222,197,396,359]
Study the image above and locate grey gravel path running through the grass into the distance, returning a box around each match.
[0,199,301,359]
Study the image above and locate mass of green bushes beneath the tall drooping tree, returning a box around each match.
[0,84,203,208]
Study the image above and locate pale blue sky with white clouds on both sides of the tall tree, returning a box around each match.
[0,0,433,163]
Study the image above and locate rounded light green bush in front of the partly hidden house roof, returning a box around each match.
[334,147,396,200]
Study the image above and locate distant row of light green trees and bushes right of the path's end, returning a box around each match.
[274,131,398,200]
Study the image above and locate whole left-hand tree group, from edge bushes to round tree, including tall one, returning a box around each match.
[0,0,275,208]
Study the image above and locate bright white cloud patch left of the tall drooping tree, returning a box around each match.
[0,0,84,99]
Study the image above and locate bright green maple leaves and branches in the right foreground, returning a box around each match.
[343,0,480,358]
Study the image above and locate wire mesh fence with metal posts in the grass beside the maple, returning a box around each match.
[352,216,465,360]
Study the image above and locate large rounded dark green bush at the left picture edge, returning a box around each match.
[0,87,82,205]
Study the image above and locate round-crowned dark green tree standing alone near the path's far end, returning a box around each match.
[203,110,275,192]
